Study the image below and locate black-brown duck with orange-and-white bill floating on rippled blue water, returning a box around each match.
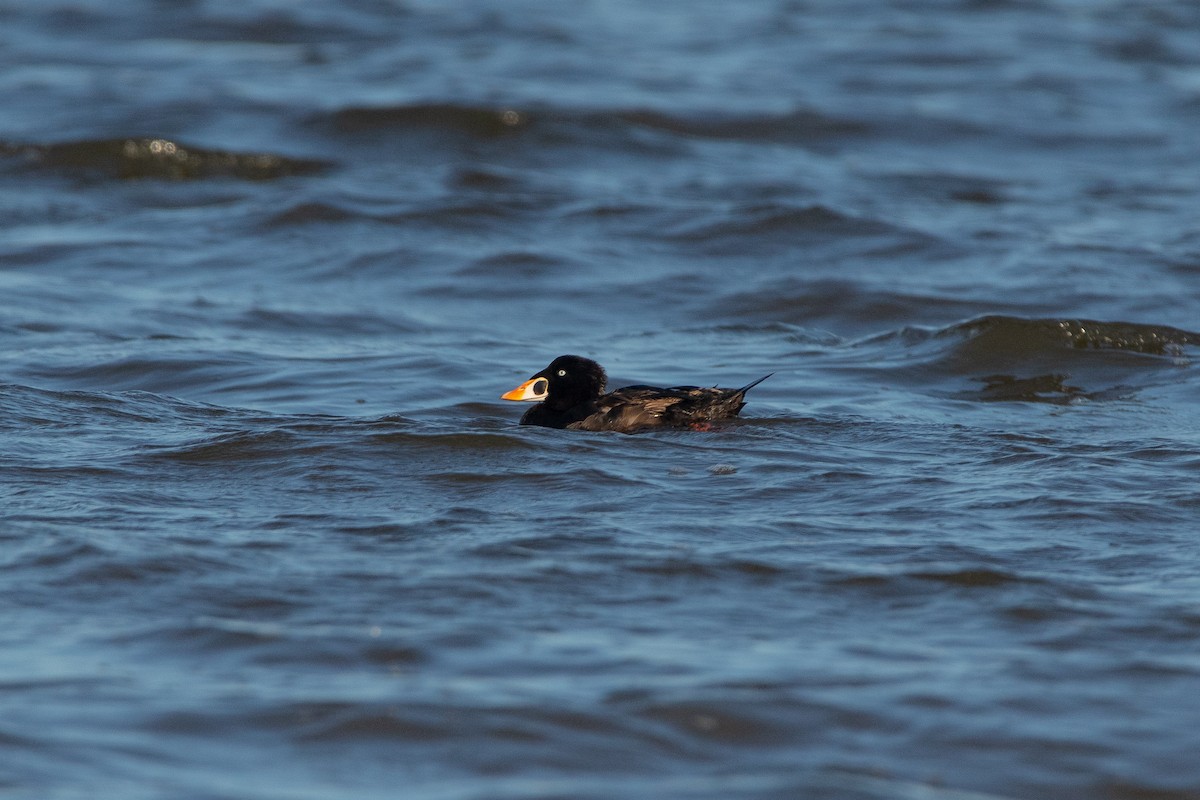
[500,355,775,433]
